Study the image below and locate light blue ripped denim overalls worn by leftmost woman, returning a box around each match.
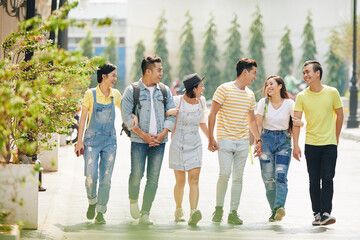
[84,89,117,213]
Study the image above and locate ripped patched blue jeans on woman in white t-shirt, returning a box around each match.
[259,129,292,210]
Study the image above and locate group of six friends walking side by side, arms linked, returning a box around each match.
[75,56,343,226]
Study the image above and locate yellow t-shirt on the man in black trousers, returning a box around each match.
[294,85,342,146]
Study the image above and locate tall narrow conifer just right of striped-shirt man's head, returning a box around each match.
[249,6,265,96]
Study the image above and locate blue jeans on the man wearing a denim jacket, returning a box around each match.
[129,142,165,214]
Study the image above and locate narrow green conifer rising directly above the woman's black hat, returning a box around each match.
[179,12,195,79]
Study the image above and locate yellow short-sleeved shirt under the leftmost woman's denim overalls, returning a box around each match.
[81,85,121,128]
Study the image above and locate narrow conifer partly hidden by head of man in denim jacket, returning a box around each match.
[154,12,172,87]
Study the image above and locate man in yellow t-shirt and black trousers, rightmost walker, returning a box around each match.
[293,61,344,226]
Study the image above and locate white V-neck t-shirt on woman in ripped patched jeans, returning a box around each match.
[257,98,294,130]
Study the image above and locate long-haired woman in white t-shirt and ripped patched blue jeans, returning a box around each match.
[256,76,302,222]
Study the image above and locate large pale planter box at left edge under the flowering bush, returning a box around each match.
[0,164,39,229]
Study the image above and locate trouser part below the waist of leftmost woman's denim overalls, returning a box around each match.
[84,131,116,213]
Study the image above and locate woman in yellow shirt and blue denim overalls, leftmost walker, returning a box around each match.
[75,63,121,224]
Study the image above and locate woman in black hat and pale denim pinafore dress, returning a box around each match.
[167,73,208,225]
